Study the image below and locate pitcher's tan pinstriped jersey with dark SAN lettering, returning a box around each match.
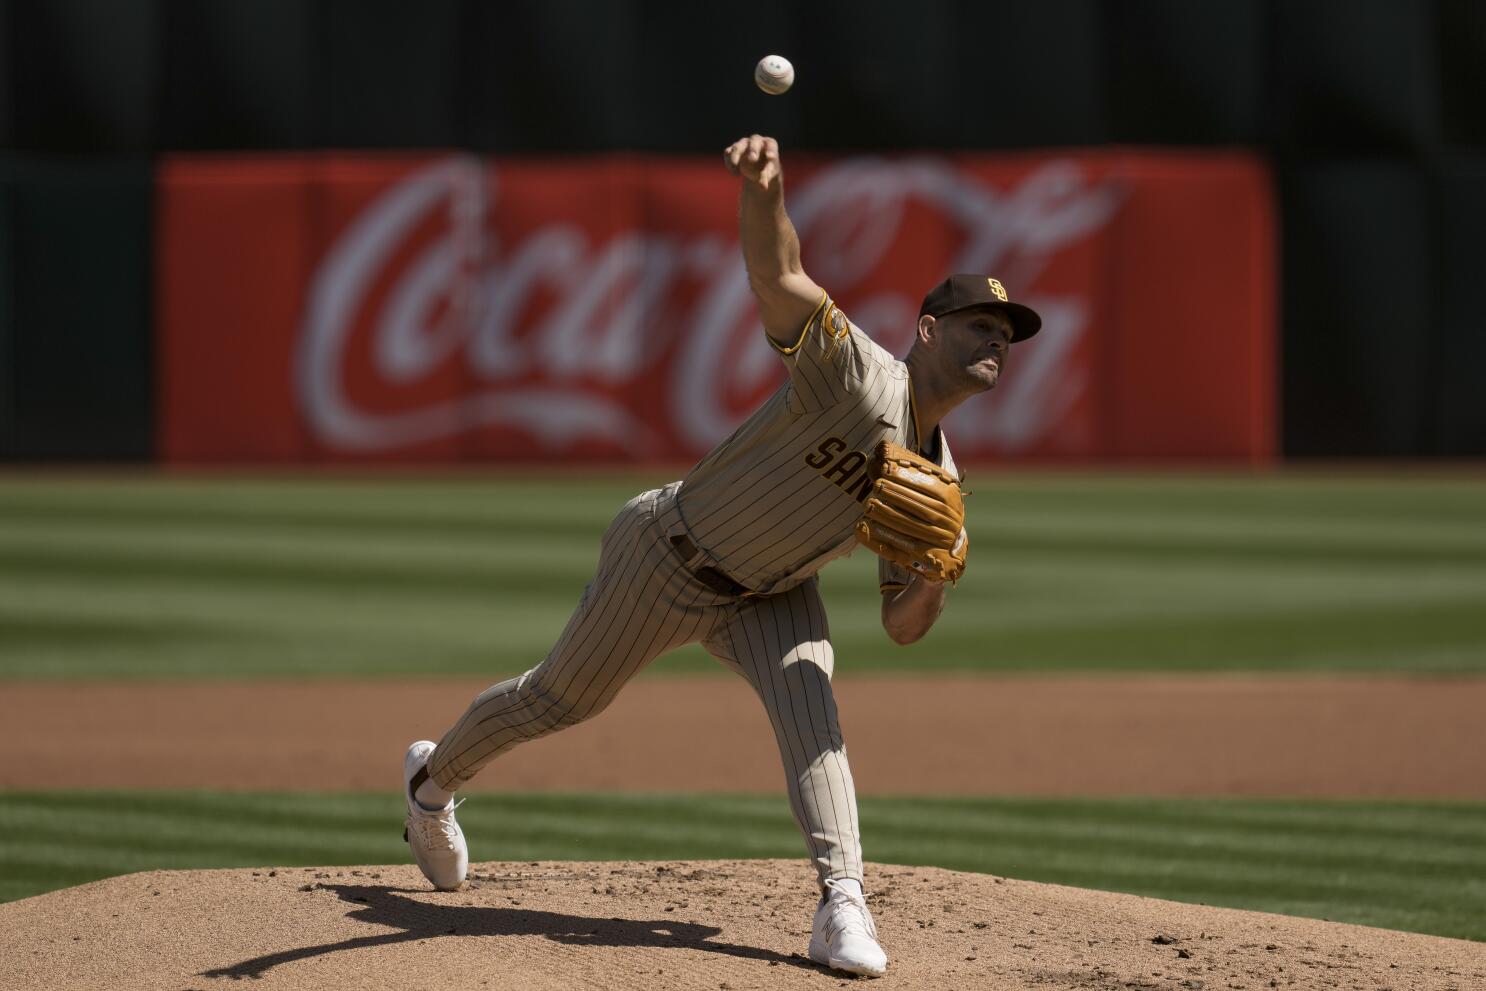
[678,293,955,593]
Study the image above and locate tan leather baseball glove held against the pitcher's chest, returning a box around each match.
[856,440,970,581]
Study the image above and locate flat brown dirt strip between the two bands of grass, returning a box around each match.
[0,676,1486,798]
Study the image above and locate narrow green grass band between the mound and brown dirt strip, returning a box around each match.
[0,792,1486,939]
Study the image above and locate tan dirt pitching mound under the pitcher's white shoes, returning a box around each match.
[0,860,1486,991]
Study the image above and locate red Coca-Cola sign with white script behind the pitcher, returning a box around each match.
[159,155,1274,462]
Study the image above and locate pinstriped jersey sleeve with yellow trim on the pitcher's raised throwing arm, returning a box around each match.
[768,293,893,410]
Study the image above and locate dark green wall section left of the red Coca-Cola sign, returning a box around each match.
[0,156,153,461]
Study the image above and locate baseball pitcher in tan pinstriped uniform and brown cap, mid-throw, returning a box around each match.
[403,134,1042,975]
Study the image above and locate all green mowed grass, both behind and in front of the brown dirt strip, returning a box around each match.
[0,471,1486,939]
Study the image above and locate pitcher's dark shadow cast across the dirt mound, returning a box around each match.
[199,884,820,981]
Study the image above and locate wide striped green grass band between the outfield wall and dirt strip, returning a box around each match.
[0,471,1486,678]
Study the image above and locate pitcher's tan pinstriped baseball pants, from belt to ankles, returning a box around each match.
[428,483,862,883]
